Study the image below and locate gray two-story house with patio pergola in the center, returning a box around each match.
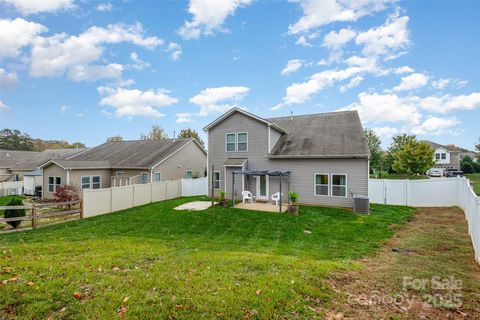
[204,108,369,207]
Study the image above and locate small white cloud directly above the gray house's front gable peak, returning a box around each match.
[189,86,250,116]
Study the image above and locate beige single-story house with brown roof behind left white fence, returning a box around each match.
[35,138,207,199]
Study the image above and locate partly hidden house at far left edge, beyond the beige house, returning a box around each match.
[0,149,86,181]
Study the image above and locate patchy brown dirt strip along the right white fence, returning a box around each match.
[327,208,480,319]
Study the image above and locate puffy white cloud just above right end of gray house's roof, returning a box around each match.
[342,92,421,126]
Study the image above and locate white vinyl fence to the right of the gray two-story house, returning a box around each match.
[368,177,480,263]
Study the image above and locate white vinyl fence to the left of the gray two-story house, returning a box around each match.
[83,178,208,218]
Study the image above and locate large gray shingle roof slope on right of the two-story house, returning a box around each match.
[267,111,369,158]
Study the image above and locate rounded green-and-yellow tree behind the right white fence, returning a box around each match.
[392,139,435,174]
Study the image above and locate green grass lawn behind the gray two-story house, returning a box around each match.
[0,198,414,319]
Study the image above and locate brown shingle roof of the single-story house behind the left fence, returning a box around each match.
[41,138,206,169]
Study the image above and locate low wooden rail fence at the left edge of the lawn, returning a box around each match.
[0,200,83,228]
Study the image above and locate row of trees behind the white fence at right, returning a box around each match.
[364,128,480,176]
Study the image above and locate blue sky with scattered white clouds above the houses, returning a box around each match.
[0,0,480,149]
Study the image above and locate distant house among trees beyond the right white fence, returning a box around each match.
[422,140,475,170]
